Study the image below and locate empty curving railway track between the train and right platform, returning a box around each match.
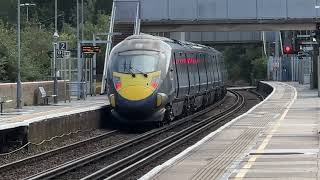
[23,91,245,179]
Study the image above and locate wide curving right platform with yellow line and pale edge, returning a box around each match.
[140,82,320,180]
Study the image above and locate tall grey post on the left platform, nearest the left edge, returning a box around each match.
[17,0,22,109]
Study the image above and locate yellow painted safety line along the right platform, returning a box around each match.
[235,82,297,180]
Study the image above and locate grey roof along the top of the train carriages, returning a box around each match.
[125,33,221,54]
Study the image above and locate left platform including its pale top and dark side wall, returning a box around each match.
[0,95,109,143]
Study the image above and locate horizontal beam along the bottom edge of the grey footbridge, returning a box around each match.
[140,19,316,33]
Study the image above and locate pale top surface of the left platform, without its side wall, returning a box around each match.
[0,95,109,130]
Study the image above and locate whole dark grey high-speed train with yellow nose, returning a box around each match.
[107,34,227,123]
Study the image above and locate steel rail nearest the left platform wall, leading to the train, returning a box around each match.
[0,130,118,171]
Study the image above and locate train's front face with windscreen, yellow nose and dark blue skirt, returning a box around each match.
[107,37,167,123]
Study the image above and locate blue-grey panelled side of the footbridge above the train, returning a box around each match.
[114,0,320,32]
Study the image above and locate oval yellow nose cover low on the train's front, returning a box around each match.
[119,85,154,101]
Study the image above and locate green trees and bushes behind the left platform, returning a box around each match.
[0,0,112,82]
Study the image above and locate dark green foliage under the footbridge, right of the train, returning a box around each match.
[223,45,267,82]
